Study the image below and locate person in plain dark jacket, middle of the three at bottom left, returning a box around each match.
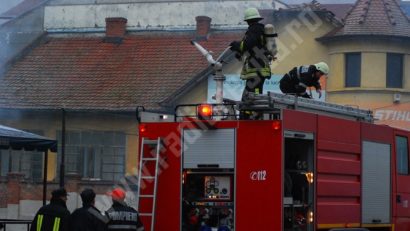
[70,189,108,231]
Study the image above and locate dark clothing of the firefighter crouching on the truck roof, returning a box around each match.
[280,65,321,96]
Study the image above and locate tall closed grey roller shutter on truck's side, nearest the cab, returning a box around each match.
[362,141,391,224]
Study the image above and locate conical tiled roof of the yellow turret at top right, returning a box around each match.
[325,0,410,37]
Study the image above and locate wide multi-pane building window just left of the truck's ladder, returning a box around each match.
[58,131,126,181]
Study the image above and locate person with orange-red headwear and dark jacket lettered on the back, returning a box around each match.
[106,188,144,231]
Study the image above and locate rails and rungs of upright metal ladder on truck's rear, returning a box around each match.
[137,137,162,231]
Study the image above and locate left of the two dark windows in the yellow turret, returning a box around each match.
[345,53,362,87]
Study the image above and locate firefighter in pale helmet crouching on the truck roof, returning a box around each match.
[279,62,329,98]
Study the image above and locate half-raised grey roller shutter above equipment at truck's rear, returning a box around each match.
[182,129,236,168]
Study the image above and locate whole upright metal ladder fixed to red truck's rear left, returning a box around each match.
[137,138,162,231]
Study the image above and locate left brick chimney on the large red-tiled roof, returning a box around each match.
[104,17,127,43]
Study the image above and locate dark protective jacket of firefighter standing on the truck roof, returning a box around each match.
[231,23,271,80]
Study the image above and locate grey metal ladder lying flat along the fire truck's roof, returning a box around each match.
[239,92,374,123]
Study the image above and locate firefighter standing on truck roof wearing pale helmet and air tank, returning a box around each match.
[230,8,272,101]
